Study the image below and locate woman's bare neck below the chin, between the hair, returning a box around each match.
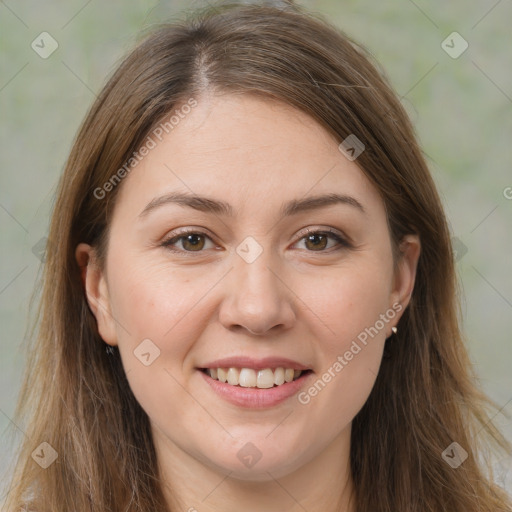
[153,425,355,512]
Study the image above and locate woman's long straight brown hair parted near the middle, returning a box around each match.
[7,4,512,512]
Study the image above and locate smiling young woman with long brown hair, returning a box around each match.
[7,1,511,512]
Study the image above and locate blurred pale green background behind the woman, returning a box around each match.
[0,0,512,496]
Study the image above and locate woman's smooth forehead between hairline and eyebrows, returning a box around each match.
[111,94,384,223]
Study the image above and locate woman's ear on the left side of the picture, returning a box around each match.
[75,243,117,346]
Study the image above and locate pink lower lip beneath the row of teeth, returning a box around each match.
[197,370,313,408]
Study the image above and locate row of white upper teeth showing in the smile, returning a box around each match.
[206,368,302,389]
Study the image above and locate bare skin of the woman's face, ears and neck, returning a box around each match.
[76,94,420,512]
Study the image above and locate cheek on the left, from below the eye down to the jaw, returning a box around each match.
[110,258,207,424]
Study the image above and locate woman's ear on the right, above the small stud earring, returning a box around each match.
[391,234,421,322]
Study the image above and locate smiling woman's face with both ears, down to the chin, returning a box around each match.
[77,95,419,480]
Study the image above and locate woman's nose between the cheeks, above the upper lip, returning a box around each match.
[219,251,295,336]
